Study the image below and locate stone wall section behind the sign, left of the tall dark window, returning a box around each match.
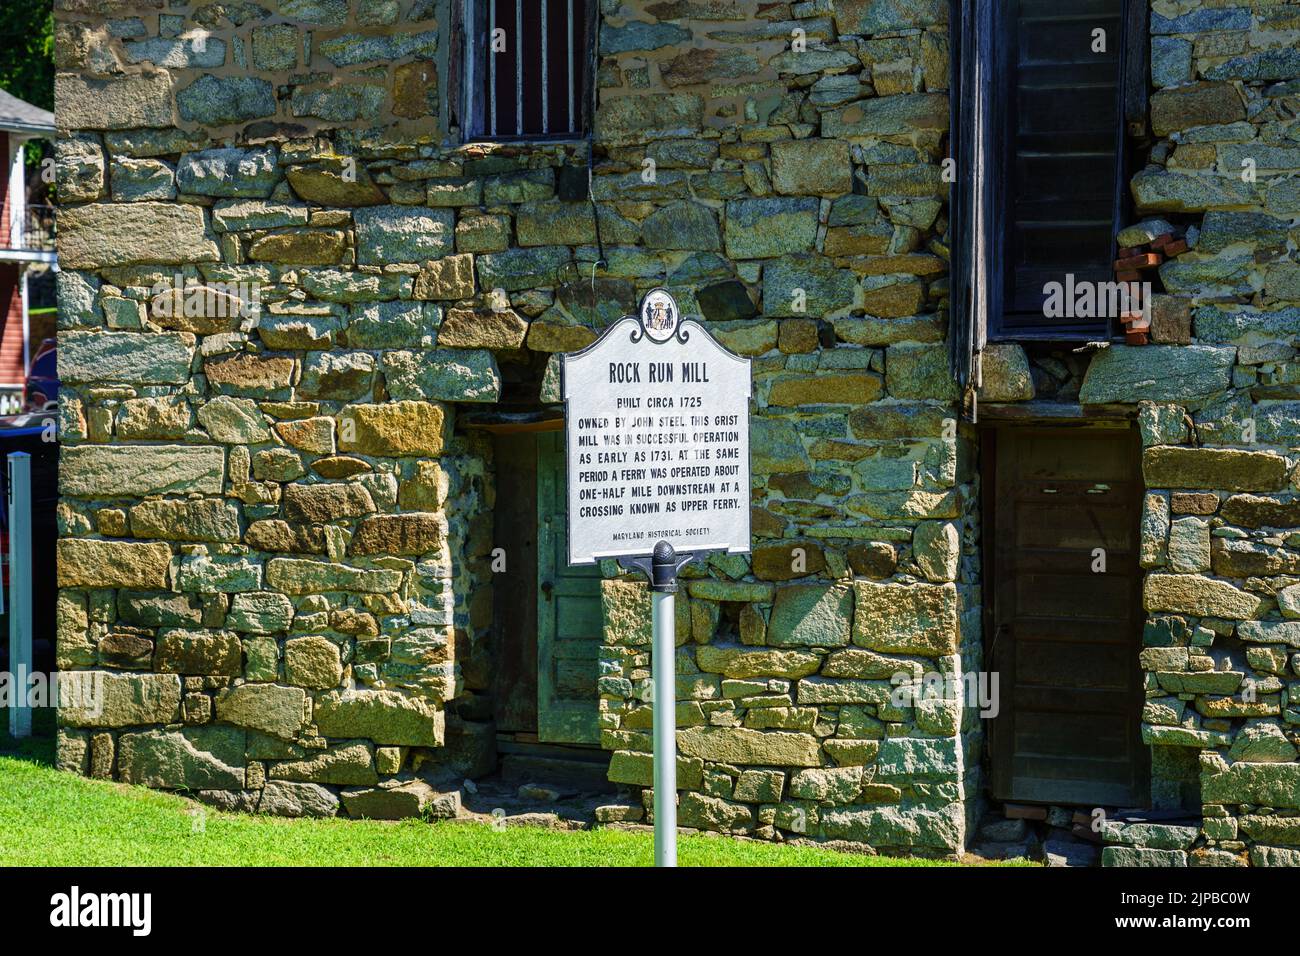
[50,0,980,852]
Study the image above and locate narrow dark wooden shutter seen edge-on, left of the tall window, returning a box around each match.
[948,0,995,401]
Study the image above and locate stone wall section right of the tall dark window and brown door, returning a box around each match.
[1102,1,1300,866]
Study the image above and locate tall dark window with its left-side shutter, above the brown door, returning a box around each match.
[949,0,1133,361]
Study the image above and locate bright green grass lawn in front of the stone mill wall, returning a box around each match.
[0,717,1013,866]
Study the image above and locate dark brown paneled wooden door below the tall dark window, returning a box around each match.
[985,427,1149,806]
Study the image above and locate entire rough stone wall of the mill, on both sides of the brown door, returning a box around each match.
[56,0,1300,864]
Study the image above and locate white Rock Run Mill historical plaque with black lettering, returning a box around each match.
[560,289,750,564]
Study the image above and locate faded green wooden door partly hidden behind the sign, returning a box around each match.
[537,432,601,744]
